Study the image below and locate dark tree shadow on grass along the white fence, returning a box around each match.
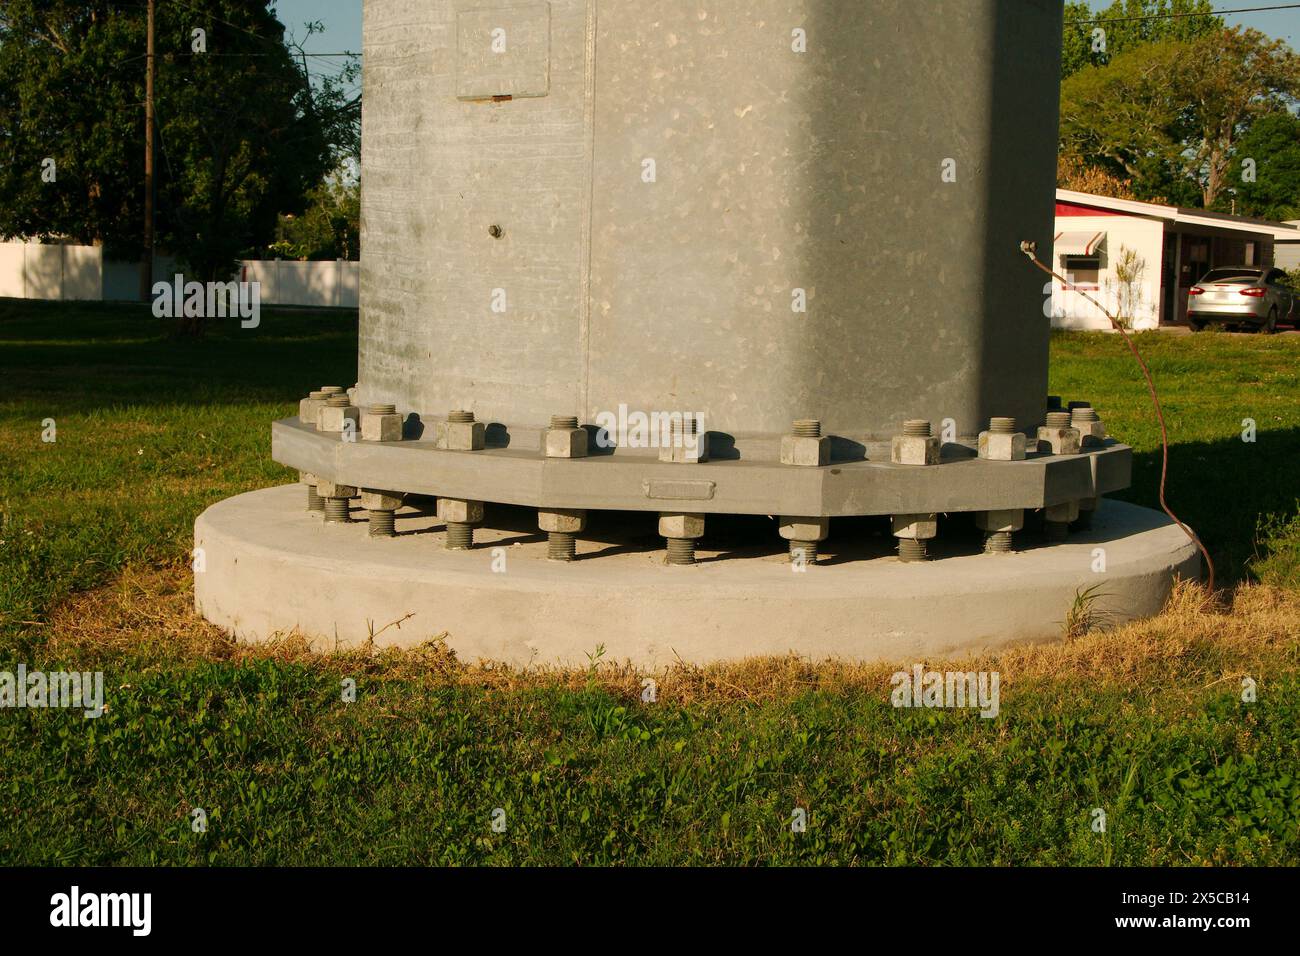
[0,299,358,415]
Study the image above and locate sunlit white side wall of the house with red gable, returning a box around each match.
[1044,216,1165,329]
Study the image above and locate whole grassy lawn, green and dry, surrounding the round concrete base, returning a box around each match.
[0,300,1300,865]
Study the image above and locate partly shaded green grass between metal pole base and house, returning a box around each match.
[1049,333,1300,583]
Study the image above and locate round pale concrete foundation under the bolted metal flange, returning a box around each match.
[194,485,1200,667]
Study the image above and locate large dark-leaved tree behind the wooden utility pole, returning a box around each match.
[0,0,359,280]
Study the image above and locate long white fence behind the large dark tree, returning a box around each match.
[0,242,361,308]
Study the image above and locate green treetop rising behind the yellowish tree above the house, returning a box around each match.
[1061,0,1223,79]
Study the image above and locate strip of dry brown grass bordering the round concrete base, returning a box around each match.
[44,566,1300,704]
